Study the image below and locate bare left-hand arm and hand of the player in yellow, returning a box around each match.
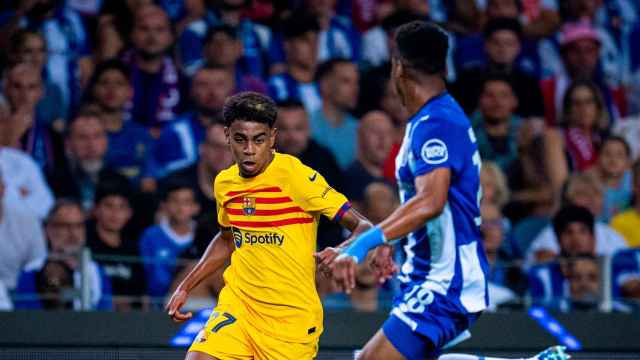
[165,229,235,322]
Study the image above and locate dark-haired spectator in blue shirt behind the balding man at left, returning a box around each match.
[88,59,153,184]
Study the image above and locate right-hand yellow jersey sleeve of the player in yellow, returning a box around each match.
[291,163,351,221]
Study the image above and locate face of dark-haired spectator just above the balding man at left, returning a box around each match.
[93,69,133,111]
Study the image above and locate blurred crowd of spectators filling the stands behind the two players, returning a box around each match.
[0,0,640,311]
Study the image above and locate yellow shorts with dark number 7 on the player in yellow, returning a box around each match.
[189,298,318,360]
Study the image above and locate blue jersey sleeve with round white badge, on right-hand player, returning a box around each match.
[411,118,469,176]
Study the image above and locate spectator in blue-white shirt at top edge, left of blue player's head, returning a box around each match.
[305,0,360,63]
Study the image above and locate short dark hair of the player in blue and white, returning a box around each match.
[395,21,449,75]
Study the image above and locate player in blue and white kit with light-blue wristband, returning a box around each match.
[320,21,568,360]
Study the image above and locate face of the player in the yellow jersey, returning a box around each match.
[226,120,277,177]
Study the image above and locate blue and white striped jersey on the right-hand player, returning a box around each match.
[396,92,488,313]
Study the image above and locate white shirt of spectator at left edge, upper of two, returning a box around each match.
[0,146,54,219]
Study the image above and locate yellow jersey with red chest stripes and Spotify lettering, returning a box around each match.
[214,153,350,342]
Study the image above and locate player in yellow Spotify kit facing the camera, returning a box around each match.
[167,92,371,360]
